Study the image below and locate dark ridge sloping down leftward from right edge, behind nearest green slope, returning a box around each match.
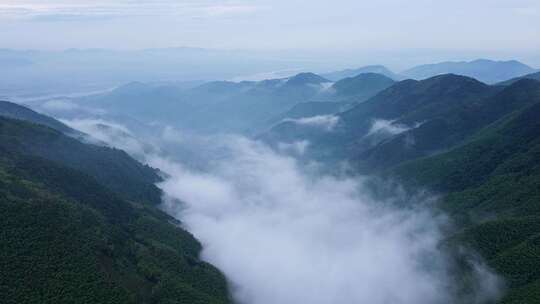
[356,79,540,168]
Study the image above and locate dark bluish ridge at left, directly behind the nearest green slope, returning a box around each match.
[0,115,161,204]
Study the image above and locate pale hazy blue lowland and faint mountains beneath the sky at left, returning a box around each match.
[0,47,330,96]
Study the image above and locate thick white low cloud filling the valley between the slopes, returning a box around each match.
[66,120,498,304]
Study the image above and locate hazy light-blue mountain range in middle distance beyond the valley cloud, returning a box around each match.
[70,73,394,134]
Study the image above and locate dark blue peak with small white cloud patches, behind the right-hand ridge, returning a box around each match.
[261,74,501,157]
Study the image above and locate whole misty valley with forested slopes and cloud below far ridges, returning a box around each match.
[0,60,540,304]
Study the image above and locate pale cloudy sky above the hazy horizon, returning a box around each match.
[0,0,540,52]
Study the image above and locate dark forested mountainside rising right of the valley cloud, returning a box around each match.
[270,75,540,304]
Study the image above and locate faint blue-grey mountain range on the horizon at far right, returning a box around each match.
[402,59,535,84]
